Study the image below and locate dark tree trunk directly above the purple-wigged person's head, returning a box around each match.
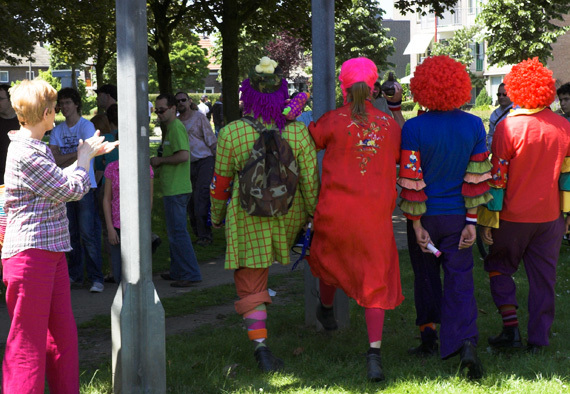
[220,0,240,124]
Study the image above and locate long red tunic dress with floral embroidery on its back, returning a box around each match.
[309,102,404,309]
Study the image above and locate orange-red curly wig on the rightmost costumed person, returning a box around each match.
[504,57,556,109]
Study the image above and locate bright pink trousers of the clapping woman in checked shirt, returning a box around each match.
[2,249,79,394]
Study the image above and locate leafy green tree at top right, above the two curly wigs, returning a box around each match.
[478,0,570,66]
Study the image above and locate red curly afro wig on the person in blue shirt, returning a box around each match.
[410,56,471,111]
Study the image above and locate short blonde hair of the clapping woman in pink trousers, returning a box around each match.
[10,79,57,126]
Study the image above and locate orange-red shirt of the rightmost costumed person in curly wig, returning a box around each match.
[492,108,570,223]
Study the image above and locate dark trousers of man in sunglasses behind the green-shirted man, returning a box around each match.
[188,156,216,240]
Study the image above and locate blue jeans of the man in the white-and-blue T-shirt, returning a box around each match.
[66,189,104,283]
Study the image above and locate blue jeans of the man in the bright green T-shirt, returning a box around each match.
[162,193,202,280]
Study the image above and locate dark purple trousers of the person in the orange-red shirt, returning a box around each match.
[485,216,564,346]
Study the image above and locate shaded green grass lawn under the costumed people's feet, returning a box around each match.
[77,246,570,394]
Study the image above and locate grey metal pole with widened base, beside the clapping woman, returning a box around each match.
[111,0,166,393]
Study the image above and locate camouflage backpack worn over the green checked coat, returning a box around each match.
[239,116,299,217]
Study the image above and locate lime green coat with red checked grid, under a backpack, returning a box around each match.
[211,120,318,269]
